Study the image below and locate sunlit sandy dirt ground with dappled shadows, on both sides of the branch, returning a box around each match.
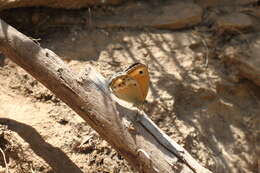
[0,1,260,173]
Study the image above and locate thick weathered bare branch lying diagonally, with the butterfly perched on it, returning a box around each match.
[0,20,210,173]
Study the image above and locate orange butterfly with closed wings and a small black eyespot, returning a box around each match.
[109,63,150,107]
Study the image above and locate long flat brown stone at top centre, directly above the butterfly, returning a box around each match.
[94,1,203,29]
